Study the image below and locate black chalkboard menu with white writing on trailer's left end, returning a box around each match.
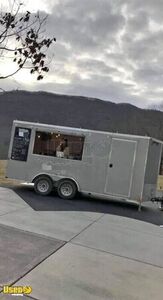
[11,127,31,161]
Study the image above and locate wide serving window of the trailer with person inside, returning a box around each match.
[33,131,84,160]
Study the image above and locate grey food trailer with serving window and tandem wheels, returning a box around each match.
[6,121,162,204]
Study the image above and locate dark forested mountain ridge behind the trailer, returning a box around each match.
[0,91,163,159]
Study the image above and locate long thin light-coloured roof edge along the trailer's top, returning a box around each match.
[13,120,163,144]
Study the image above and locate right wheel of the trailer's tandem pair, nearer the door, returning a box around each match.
[57,179,77,199]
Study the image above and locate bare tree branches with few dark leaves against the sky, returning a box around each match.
[0,0,56,80]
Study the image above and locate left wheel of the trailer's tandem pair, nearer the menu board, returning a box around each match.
[34,176,53,196]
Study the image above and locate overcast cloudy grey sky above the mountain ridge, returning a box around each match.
[0,0,163,107]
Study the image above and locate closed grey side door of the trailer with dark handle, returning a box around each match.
[105,138,137,197]
